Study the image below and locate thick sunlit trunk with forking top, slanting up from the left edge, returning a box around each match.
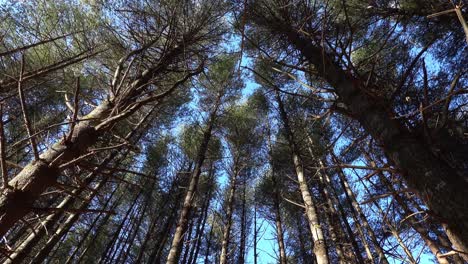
[0,41,197,237]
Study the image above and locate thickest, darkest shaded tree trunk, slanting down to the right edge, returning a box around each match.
[260,19,468,260]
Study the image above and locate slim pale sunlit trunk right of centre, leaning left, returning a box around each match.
[275,89,329,264]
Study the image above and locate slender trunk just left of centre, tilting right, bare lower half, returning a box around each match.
[166,93,222,264]
